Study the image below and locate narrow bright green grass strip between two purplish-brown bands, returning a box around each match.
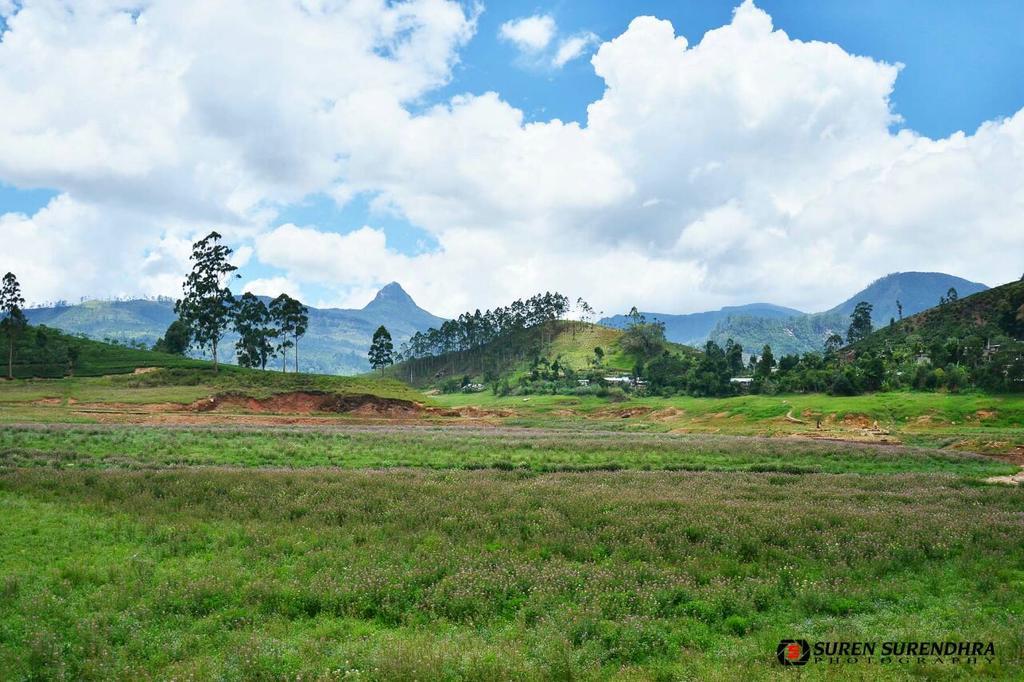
[0,426,1018,478]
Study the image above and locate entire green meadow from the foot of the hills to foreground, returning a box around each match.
[0,369,1024,680]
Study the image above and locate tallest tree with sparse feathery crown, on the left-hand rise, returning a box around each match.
[174,231,241,372]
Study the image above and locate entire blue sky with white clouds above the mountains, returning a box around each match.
[0,0,1024,315]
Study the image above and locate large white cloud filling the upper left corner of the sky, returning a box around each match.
[0,0,475,298]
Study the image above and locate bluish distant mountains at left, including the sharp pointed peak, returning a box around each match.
[26,282,444,374]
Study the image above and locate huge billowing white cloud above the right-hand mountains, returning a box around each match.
[315,3,1024,313]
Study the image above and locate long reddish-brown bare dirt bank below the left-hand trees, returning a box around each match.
[187,391,423,418]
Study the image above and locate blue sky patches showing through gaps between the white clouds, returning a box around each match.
[262,0,1024,305]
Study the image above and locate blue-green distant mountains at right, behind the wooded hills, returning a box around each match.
[601,272,988,356]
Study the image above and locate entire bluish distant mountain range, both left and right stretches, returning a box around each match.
[27,272,988,374]
